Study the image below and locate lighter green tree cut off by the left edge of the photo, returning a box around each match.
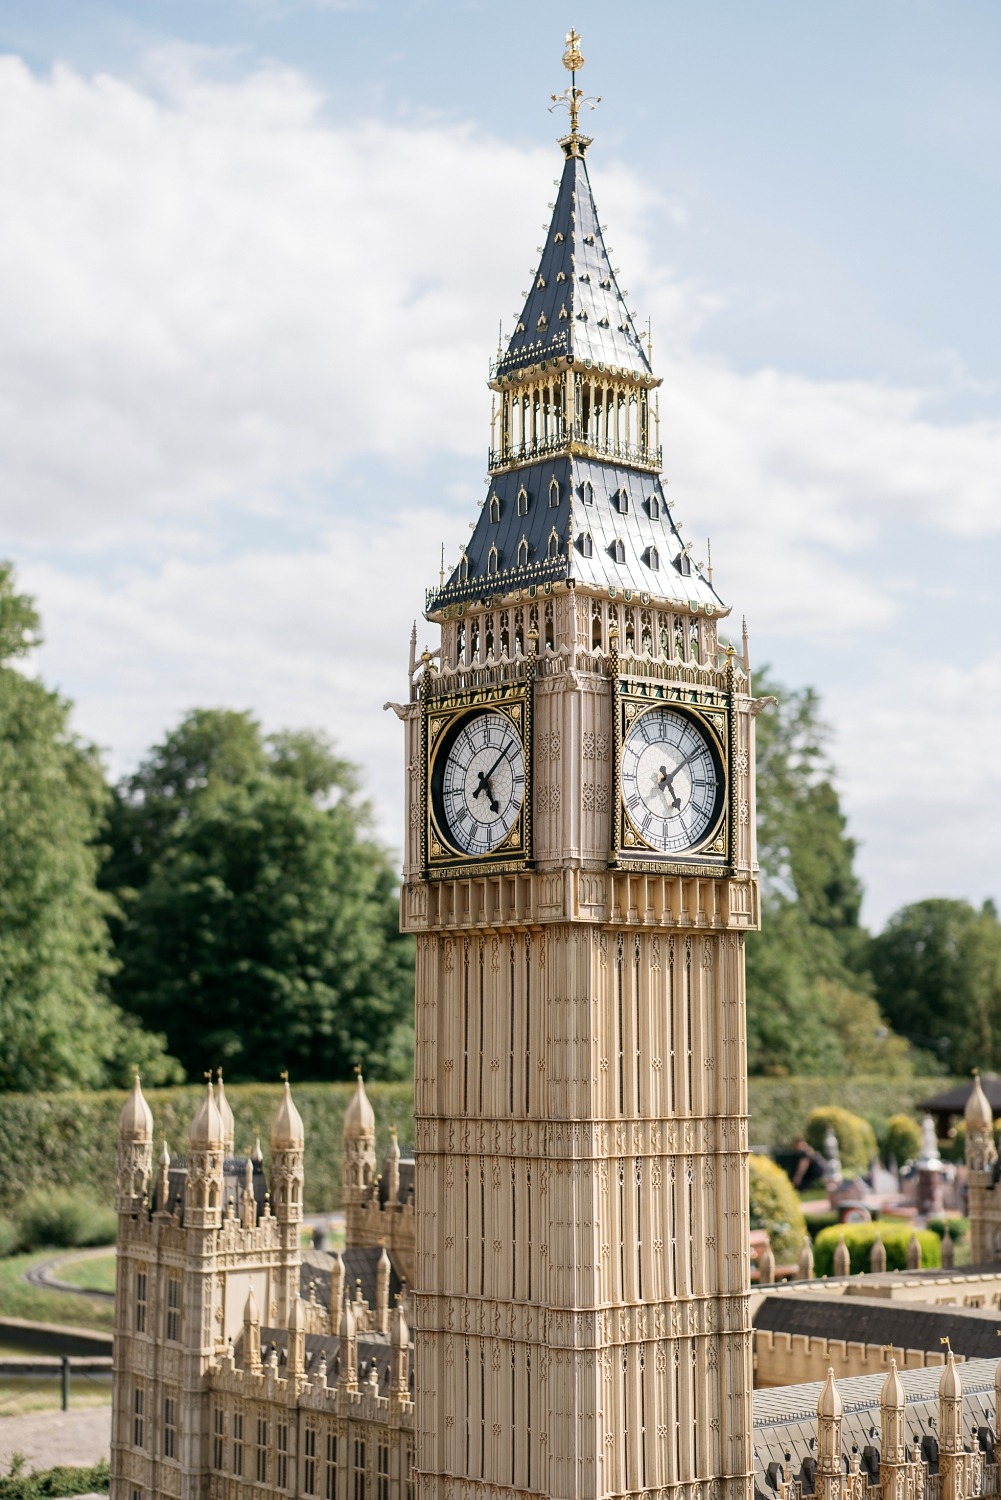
[0,563,179,1091]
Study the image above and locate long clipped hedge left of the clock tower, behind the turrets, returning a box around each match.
[0,1083,414,1218]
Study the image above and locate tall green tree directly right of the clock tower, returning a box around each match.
[747,671,911,1074]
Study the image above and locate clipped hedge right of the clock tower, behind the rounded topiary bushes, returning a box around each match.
[747,1076,963,1166]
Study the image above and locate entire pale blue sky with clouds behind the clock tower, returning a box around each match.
[0,0,1001,924]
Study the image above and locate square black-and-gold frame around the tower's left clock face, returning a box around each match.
[420,683,533,881]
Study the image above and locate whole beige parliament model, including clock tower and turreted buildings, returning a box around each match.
[111,33,998,1500]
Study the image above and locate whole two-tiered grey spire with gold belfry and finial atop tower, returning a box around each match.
[426,32,726,617]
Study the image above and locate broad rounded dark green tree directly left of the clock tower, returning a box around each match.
[107,710,413,1080]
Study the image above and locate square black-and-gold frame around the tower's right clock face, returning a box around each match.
[609,678,734,876]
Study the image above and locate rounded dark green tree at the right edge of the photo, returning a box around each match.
[870,900,1001,1073]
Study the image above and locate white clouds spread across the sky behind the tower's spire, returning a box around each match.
[0,48,1001,905]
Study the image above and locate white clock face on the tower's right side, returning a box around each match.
[621,708,723,854]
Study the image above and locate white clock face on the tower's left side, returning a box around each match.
[432,710,525,855]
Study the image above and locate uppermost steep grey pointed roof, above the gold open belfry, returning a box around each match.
[497,156,653,378]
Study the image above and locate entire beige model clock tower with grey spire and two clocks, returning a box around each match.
[401,32,758,1500]
